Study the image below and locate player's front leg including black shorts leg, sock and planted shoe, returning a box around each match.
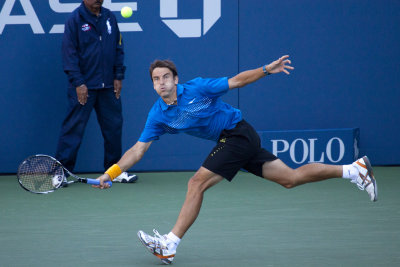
[138,122,254,264]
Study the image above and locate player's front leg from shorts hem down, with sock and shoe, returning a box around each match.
[138,167,223,264]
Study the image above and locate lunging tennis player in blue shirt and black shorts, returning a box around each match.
[98,55,377,264]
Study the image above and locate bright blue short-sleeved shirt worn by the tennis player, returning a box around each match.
[139,77,242,143]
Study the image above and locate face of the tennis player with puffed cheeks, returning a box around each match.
[152,68,178,101]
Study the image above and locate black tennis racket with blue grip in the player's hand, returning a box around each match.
[17,154,112,194]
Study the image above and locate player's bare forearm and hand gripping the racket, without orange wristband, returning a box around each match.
[94,141,153,188]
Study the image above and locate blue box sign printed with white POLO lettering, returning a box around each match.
[258,128,360,168]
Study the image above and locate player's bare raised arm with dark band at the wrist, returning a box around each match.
[228,55,294,89]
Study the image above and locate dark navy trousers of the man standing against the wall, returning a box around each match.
[55,88,122,171]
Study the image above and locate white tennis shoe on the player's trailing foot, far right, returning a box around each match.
[351,156,378,201]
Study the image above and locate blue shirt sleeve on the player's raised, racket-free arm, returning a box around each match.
[187,77,229,98]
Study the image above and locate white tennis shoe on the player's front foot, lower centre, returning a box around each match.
[138,229,176,264]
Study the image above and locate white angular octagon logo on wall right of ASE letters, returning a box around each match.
[160,0,221,38]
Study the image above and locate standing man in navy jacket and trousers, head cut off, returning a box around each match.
[55,0,137,182]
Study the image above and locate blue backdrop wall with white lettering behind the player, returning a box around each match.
[0,0,400,173]
